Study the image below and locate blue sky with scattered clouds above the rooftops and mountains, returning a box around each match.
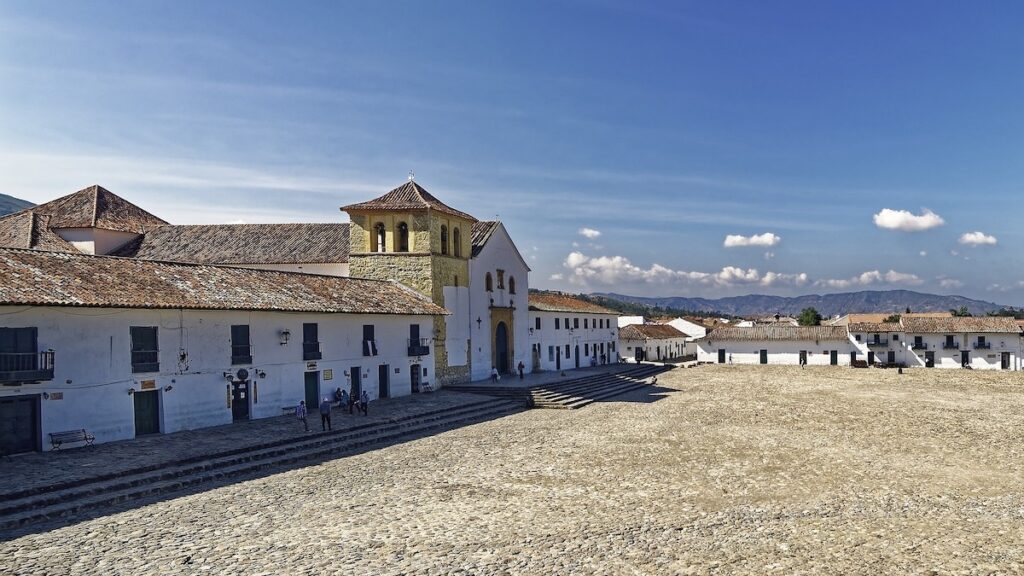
[0,0,1024,304]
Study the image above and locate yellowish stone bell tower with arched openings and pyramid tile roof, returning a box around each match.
[342,177,476,385]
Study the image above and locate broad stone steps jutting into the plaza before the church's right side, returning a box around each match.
[530,364,672,410]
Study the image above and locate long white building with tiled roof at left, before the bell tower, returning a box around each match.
[0,248,446,453]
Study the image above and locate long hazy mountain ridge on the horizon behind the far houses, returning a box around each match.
[593,290,1009,318]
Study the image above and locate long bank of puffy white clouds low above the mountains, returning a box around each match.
[563,252,808,287]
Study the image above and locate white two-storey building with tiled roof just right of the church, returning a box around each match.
[524,292,618,370]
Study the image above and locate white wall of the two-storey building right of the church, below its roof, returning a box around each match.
[529,311,620,370]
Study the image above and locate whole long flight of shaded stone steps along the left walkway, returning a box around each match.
[0,399,522,538]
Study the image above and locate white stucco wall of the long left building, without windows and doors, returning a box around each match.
[0,306,434,450]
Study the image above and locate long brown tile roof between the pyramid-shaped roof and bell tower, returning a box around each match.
[112,223,348,264]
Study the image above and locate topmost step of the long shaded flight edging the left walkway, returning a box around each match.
[0,399,503,502]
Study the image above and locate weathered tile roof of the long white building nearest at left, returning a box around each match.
[0,248,447,315]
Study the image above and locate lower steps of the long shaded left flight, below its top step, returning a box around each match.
[0,401,521,530]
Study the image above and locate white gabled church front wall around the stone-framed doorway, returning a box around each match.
[469,225,530,380]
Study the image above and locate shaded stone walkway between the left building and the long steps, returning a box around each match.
[0,390,485,495]
